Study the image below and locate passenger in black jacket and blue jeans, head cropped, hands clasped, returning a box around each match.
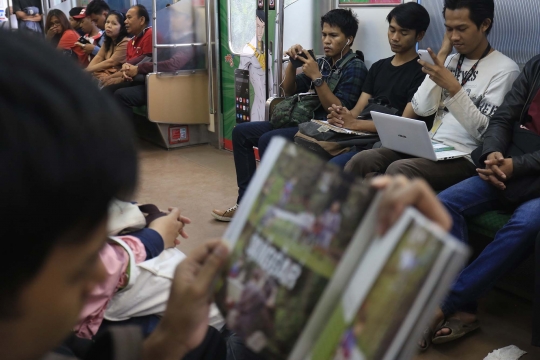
[424,56,540,346]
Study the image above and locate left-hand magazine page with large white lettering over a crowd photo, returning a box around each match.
[221,139,375,359]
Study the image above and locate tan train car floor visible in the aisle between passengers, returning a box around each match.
[135,141,540,360]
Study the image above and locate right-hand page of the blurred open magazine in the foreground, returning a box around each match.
[310,209,469,360]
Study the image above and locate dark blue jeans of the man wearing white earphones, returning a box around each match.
[232,121,298,204]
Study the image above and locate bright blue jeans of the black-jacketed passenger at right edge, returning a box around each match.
[439,176,540,316]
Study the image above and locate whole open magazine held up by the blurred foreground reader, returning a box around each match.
[216,138,468,359]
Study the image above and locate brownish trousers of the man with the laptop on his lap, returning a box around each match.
[345,148,476,190]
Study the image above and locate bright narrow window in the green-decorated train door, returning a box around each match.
[229,0,257,54]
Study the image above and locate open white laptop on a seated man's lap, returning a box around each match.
[371,111,469,161]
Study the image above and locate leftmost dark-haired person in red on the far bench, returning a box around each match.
[45,9,89,67]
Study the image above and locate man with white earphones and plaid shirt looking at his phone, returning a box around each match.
[212,9,367,221]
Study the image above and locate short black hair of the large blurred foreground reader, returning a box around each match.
[0,31,137,318]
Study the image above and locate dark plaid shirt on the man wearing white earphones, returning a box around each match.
[296,50,368,120]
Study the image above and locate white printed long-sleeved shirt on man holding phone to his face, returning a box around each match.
[412,50,519,160]
